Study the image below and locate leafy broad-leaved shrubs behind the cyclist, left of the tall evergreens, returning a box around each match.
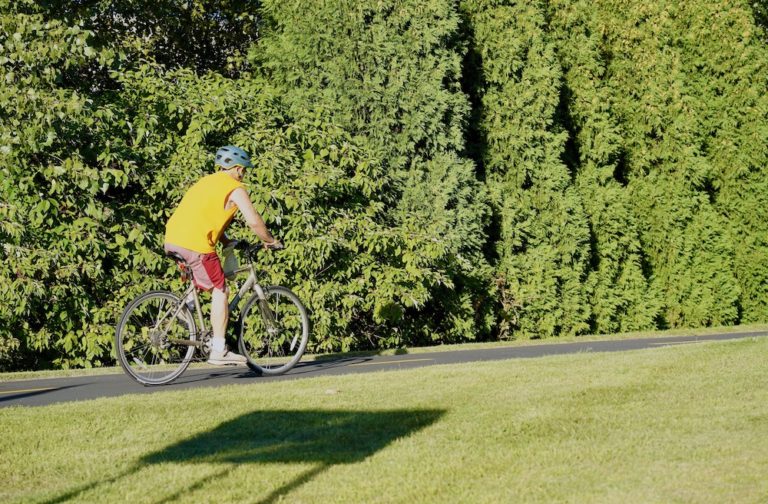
[2,0,489,367]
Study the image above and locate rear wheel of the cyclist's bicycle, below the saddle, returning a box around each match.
[115,291,197,385]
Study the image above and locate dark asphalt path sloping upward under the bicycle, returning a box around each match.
[0,331,768,407]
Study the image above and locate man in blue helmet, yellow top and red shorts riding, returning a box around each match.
[164,145,280,365]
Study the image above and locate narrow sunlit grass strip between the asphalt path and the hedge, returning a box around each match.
[0,324,768,382]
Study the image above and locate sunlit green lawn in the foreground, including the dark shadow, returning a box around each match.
[0,338,768,503]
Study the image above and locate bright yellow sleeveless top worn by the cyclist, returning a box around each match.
[165,172,243,254]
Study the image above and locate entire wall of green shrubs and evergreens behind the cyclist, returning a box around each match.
[0,0,768,369]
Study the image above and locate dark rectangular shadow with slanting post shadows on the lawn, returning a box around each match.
[40,410,444,504]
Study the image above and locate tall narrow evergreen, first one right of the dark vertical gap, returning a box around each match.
[462,1,590,337]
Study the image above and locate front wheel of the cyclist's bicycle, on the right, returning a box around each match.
[238,286,309,376]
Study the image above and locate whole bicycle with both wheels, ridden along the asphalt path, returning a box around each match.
[115,242,309,385]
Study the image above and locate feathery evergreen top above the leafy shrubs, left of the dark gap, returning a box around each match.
[251,0,468,171]
